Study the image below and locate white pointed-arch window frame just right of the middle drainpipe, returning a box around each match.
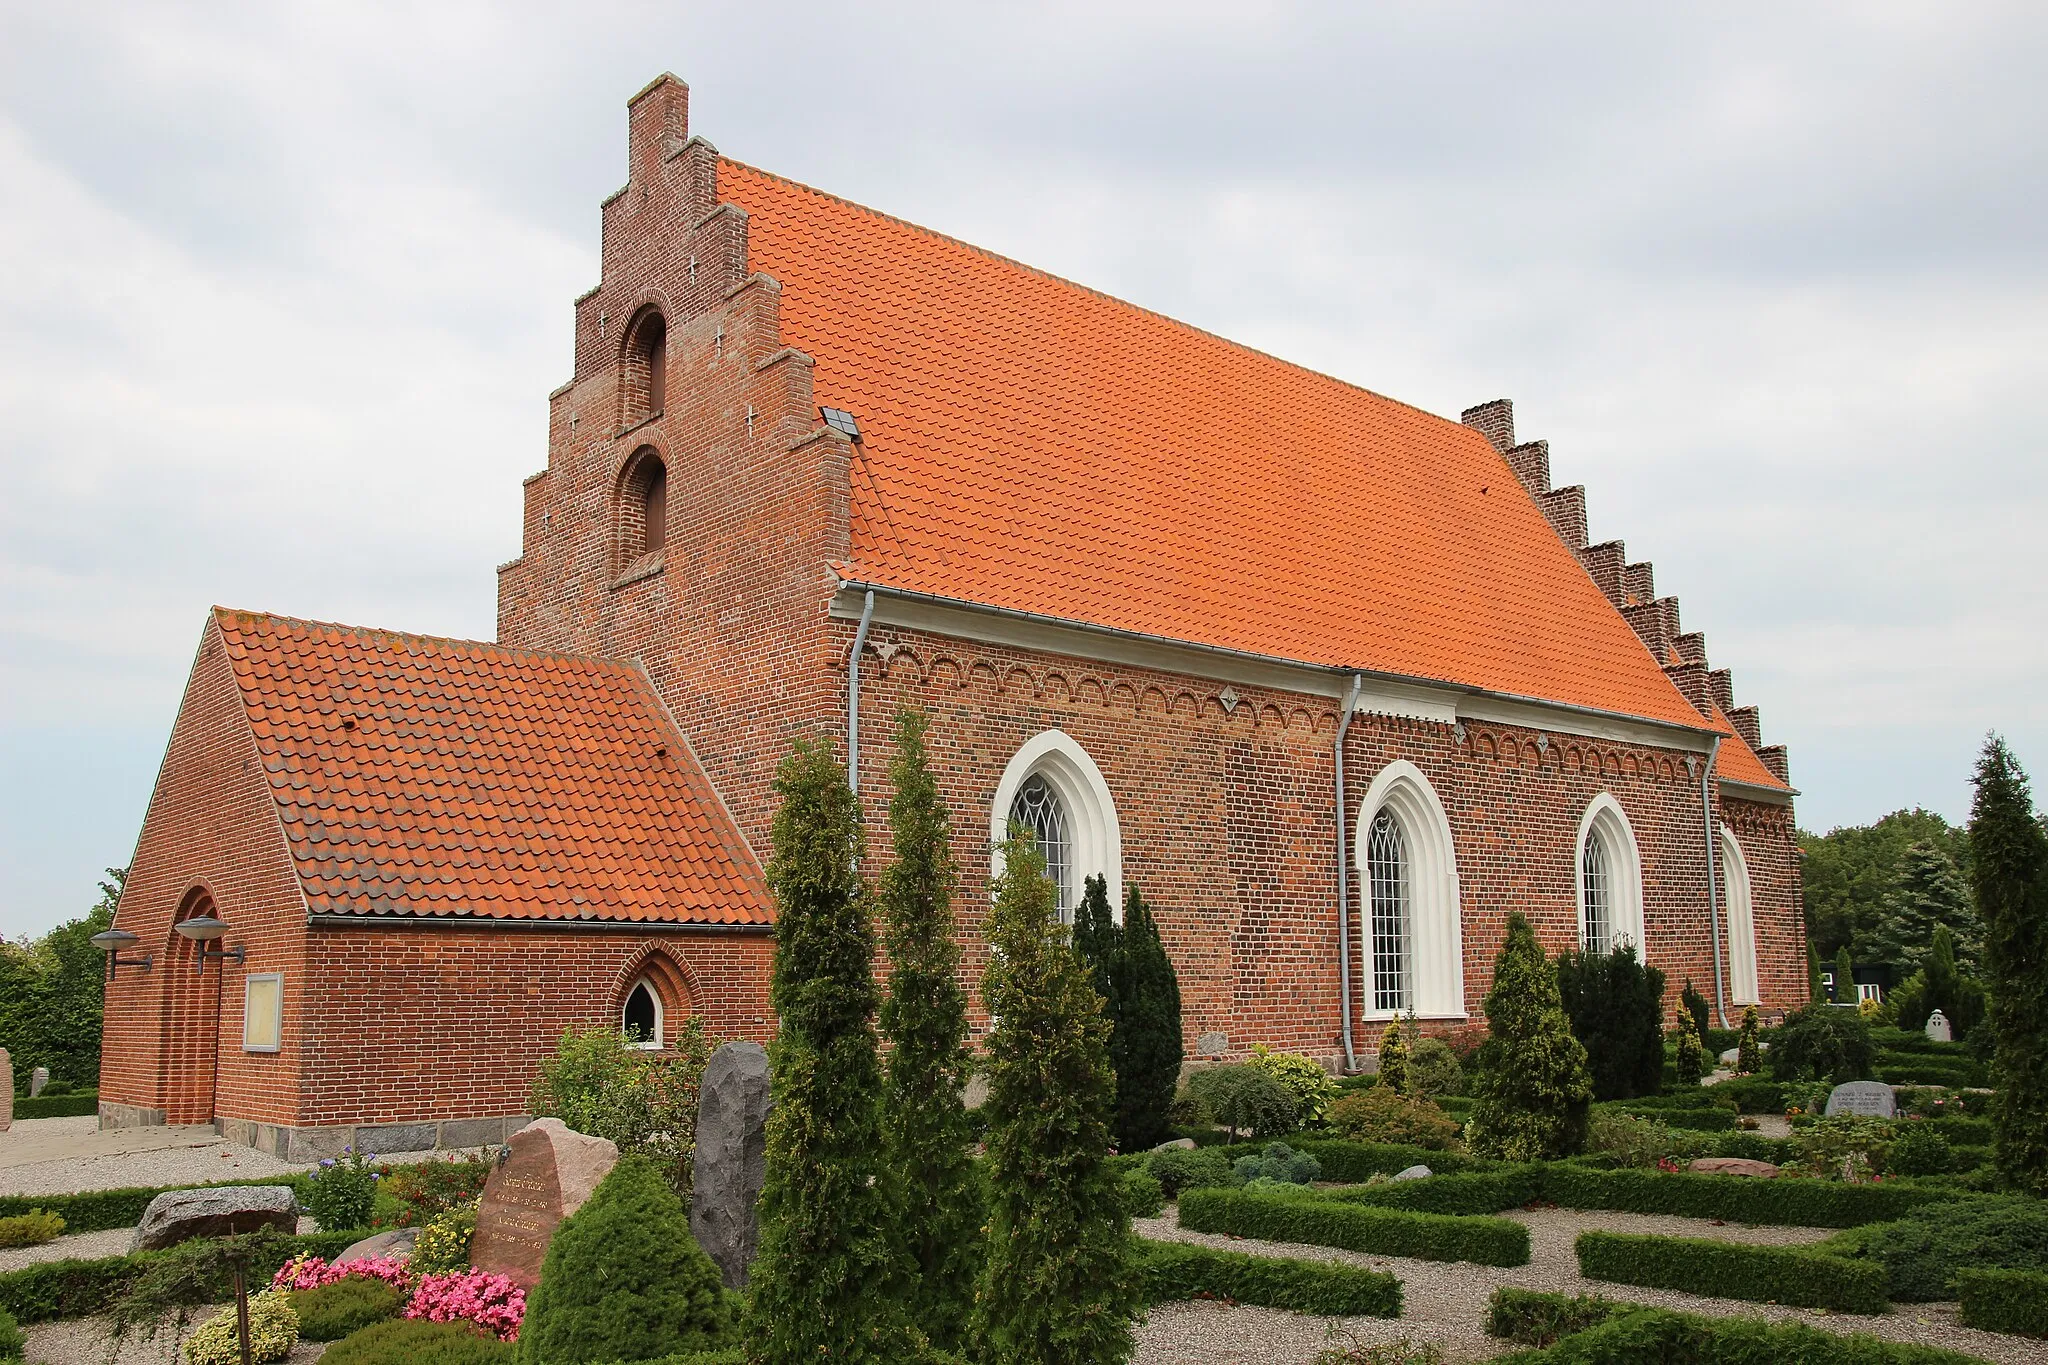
[1352,759,1466,1019]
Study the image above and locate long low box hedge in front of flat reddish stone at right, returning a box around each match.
[1542,1162,1958,1228]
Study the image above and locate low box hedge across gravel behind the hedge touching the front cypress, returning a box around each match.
[1180,1189,1530,1265]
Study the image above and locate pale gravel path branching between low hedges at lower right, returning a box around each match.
[1133,1207,2048,1365]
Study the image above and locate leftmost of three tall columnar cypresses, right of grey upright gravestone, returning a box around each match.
[748,741,911,1365]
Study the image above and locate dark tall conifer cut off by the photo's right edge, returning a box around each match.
[1970,735,2048,1195]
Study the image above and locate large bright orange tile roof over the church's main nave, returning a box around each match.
[719,162,1706,729]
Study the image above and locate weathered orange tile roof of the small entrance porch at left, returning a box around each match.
[213,608,772,925]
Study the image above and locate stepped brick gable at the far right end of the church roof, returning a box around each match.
[1460,399,1796,796]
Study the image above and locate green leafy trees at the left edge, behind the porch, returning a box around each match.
[0,868,127,1095]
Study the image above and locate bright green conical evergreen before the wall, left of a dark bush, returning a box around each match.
[1470,911,1593,1160]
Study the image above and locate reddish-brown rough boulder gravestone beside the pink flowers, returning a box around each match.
[469,1119,618,1291]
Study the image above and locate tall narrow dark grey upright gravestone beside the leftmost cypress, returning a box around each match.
[690,1044,768,1289]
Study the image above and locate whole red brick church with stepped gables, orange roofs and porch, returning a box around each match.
[100,76,1806,1156]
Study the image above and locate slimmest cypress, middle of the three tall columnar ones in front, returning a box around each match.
[881,710,981,1351]
